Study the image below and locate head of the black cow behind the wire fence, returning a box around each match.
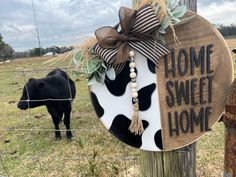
[17,78,45,110]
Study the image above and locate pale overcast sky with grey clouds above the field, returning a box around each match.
[0,0,236,51]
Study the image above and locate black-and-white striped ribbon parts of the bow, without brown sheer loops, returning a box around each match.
[94,5,169,74]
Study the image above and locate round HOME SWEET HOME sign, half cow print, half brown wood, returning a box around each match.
[90,12,233,151]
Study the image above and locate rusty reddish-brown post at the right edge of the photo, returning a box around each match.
[224,79,236,177]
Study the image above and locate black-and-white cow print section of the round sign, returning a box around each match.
[90,51,163,151]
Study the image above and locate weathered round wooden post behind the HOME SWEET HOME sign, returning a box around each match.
[133,0,197,177]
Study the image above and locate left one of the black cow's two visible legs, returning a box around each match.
[48,108,63,140]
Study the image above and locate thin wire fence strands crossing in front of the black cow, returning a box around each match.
[0,67,140,177]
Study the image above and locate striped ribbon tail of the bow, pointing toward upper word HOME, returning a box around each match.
[129,39,170,68]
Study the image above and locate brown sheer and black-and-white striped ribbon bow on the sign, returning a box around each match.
[94,5,169,74]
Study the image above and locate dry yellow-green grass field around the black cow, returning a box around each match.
[0,39,236,177]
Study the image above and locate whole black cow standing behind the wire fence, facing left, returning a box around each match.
[17,69,76,140]
